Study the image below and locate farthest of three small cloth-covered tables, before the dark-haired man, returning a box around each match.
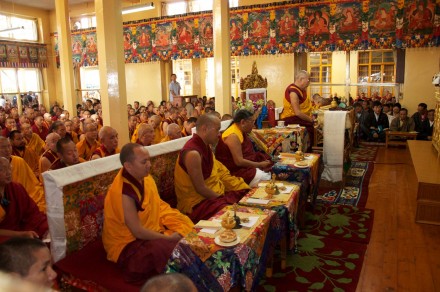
[272,153,323,226]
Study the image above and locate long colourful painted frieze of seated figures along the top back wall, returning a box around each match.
[55,0,440,66]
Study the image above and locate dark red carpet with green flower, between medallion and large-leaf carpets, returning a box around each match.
[301,204,374,244]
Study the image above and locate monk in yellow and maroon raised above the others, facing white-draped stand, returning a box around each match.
[280,70,314,152]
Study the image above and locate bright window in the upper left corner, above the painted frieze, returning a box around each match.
[0,14,38,42]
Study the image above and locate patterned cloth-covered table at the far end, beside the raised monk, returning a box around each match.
[249,127,310,158]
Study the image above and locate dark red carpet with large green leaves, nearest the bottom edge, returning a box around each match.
[257,233,367,292]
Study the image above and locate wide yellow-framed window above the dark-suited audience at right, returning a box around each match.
[358,50,395,96]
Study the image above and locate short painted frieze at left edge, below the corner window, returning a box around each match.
[0,41,47,68]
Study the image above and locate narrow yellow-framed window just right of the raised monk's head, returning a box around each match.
[308,53,332,97]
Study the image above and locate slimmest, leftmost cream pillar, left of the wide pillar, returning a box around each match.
[55,0,76,114]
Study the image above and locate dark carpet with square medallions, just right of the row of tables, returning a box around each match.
[316,161,374,207]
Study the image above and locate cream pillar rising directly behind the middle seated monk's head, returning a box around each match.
[212,0,232,115]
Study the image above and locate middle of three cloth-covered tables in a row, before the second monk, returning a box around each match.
[239,181,300,250]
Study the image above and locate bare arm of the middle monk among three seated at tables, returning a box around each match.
[183,151,219,199]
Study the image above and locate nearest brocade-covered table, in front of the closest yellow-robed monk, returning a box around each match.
[166,206,281,291]
